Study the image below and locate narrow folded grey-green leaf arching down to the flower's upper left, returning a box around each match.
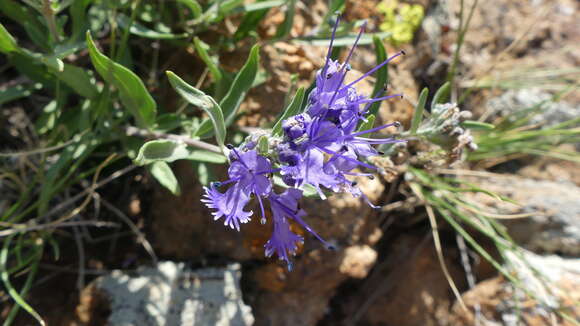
[166,71,226,148]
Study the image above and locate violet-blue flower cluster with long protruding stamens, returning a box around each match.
[202,18,403,269]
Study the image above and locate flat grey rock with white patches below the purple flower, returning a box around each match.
[77,261,254,326]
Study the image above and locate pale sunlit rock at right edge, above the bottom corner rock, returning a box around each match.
[467,176,580,256]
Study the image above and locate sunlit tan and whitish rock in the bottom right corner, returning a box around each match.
[452,251,580,326]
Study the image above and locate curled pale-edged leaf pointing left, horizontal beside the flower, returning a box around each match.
[135,139,227,165]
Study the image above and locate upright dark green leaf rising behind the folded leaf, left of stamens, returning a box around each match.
[196,45,260,137]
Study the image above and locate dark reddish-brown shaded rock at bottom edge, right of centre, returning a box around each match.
[323,233,466,326]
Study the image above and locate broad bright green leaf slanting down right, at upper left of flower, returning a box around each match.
[87,31,157,128]
